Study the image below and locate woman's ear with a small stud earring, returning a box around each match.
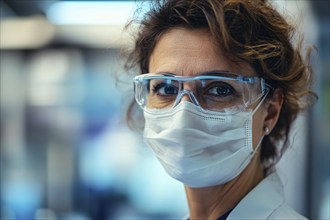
[264,88,284,133]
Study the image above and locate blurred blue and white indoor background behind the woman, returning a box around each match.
[0,0,330,220]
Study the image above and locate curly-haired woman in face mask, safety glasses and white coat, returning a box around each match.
[127,0,316,219]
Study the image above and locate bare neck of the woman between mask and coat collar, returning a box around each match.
[185,157,264,219]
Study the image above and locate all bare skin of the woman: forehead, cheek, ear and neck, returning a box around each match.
[149,28,283,219]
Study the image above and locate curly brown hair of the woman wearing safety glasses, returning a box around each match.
[126,0,317,171]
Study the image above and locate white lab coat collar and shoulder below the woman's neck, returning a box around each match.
[227,173,306,220]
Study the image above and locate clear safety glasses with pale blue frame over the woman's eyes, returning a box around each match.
[134,73,265,113]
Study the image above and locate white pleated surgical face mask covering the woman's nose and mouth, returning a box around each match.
[144,101,262,188]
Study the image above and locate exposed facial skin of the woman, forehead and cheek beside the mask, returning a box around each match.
[149,28,267,146]
